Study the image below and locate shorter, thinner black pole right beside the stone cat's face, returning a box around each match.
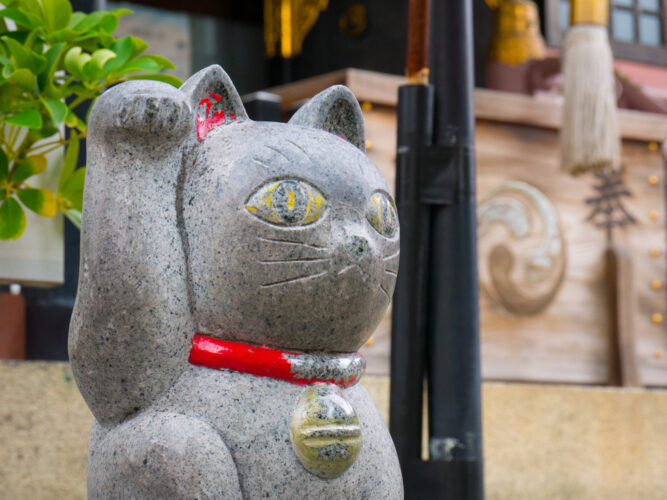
[389,84,433,464]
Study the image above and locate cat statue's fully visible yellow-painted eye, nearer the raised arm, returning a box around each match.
[245,179,327,226]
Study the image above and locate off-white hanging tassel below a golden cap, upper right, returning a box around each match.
[561,25,621,175]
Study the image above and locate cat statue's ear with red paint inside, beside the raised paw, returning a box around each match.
[180,64,248,142]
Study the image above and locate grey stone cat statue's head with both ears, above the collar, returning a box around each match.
[179,66,399,351]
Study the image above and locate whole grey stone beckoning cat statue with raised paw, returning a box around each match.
[69,66,403,499]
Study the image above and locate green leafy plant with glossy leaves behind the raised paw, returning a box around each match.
[0,0,181,240]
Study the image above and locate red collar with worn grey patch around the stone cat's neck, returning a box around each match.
[188,333,366,388]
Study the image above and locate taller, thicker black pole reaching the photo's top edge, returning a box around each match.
[427,0,484,499]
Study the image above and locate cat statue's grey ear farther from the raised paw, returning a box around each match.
[289,85,366,152]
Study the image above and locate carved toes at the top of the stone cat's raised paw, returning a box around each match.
[115,94,192,140]
